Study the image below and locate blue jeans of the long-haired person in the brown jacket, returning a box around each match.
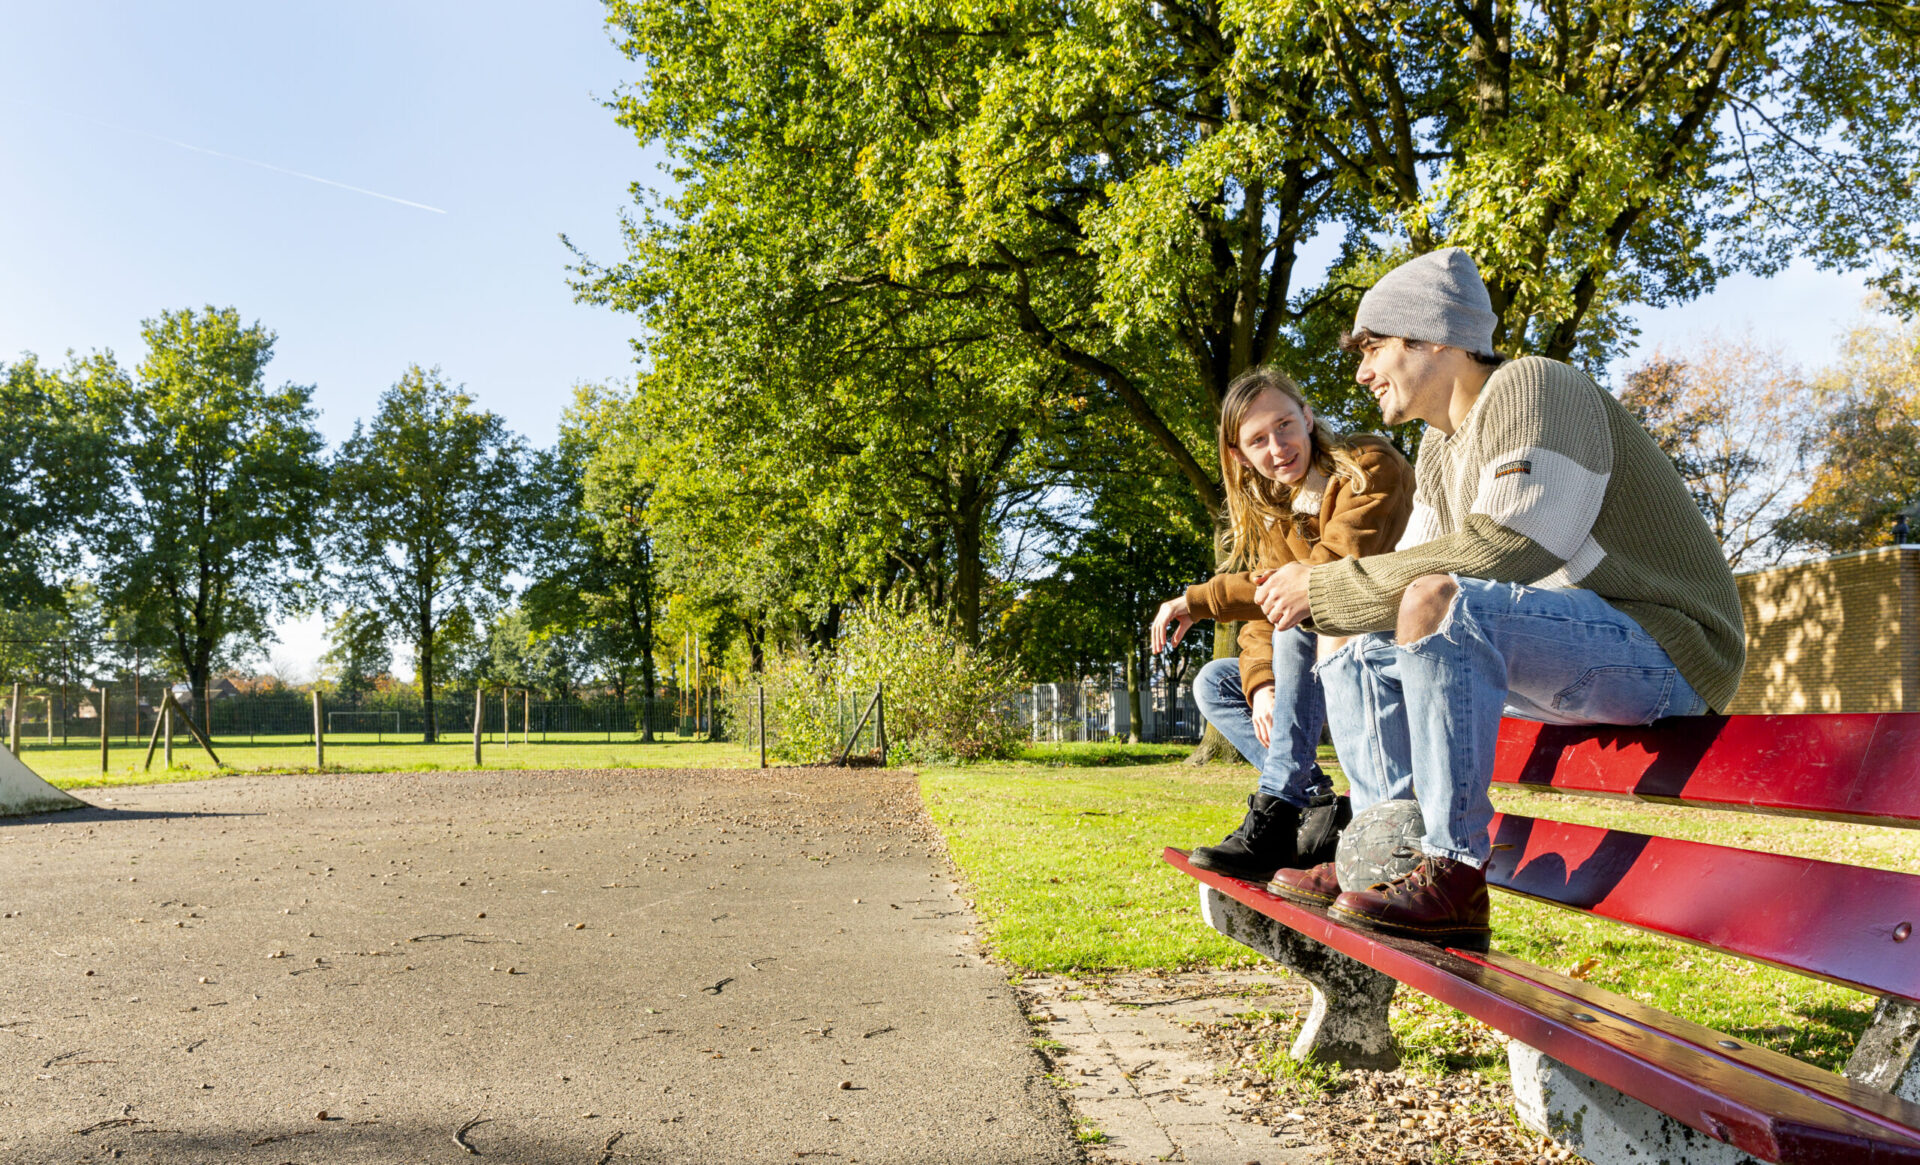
[1194,628,1332,808]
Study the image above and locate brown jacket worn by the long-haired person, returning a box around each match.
[1187,434,1413,701]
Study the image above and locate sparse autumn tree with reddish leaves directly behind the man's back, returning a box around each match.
[1620,336,1814,570]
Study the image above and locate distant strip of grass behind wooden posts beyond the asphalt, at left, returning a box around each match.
[21,733,760,789]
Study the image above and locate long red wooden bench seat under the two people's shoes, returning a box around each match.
[1164,846,1920,1165]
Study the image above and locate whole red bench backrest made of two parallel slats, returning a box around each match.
[1488,714,1920,1000]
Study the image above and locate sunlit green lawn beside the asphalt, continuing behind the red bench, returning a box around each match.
[922,747,1896,1071]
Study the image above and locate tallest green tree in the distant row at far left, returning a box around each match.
[88,307,326,733]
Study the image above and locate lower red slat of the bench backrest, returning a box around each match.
[1486,814,1920,1000]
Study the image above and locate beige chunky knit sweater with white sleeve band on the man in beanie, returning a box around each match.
[1309,357,1747,710]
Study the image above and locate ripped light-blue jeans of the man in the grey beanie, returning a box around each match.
[1319,576,1709,866]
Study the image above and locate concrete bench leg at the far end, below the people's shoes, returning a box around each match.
[1200,885,1400,1071]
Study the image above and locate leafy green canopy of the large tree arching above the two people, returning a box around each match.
[586,0,1920,525]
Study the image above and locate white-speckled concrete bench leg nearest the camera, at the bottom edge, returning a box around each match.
[1507,1040,1761,1165]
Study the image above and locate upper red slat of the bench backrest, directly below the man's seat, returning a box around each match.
[1494,712,1920,827]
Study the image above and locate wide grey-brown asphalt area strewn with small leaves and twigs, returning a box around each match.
[0,770,1081,1165]
